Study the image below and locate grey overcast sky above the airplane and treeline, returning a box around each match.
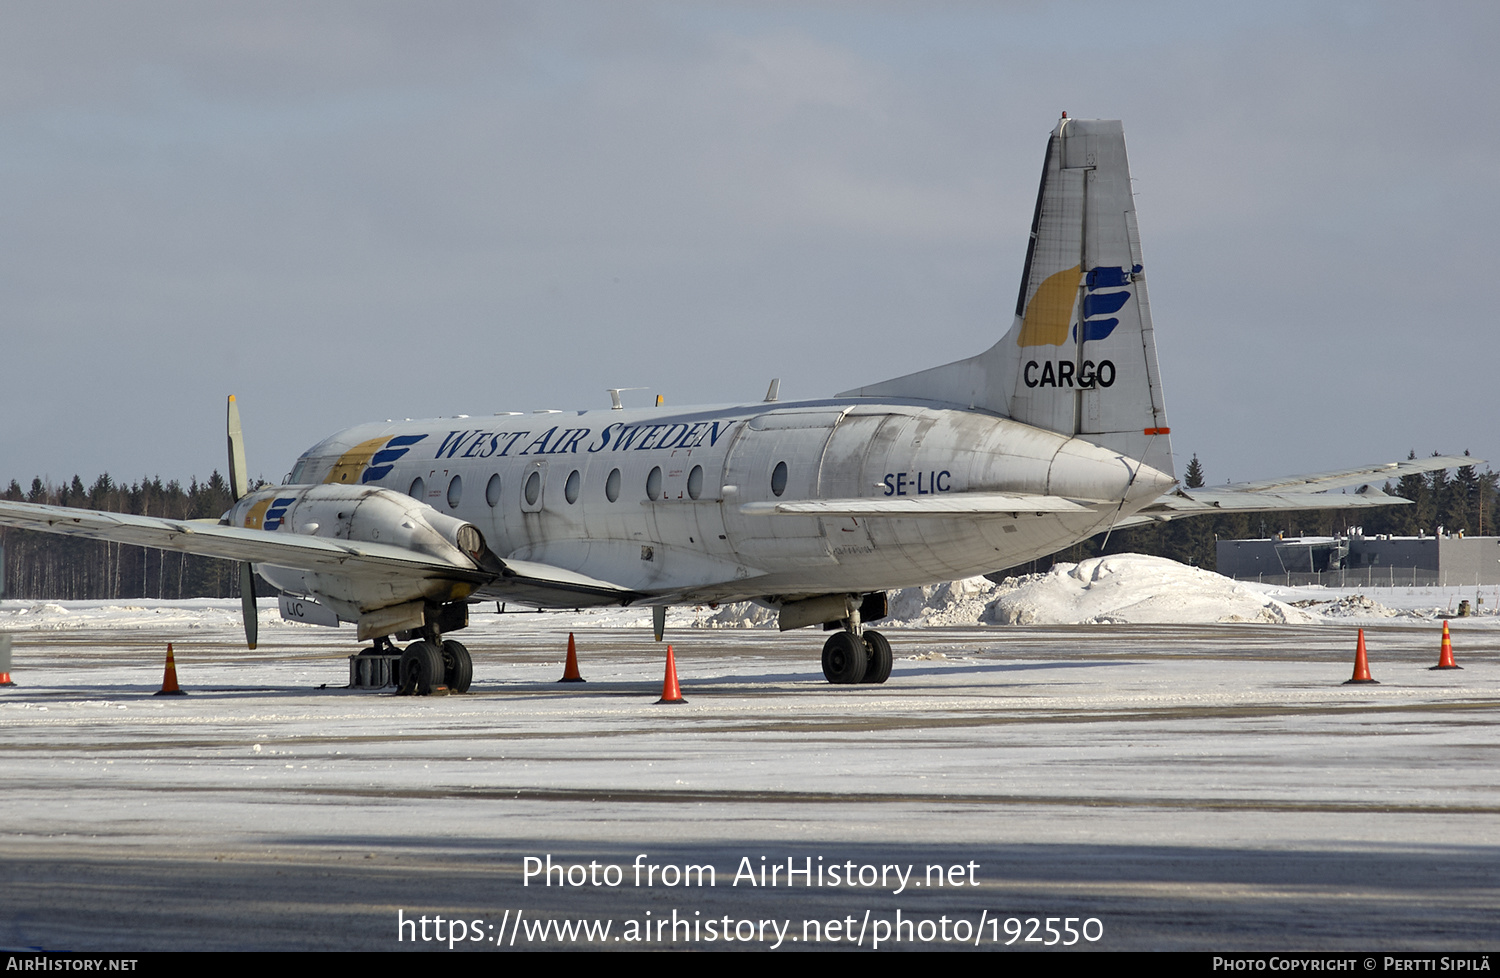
[0,0,1500,483]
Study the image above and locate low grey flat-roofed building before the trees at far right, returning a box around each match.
[1217,528,1500,587]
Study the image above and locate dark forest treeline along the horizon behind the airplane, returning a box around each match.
[0,453,1500,600]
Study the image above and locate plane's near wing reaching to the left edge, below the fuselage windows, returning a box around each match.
[0,500,639,606]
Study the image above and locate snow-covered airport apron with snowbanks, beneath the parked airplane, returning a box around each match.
[0,558,1500,951]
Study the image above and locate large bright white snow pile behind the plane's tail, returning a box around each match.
[981,554,1317,626]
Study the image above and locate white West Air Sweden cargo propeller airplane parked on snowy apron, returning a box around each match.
[0,114,1479,693]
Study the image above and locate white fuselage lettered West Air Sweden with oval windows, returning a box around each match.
[273,401,1172,602]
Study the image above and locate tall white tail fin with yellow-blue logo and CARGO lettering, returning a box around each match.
[846,117,1175,473]
